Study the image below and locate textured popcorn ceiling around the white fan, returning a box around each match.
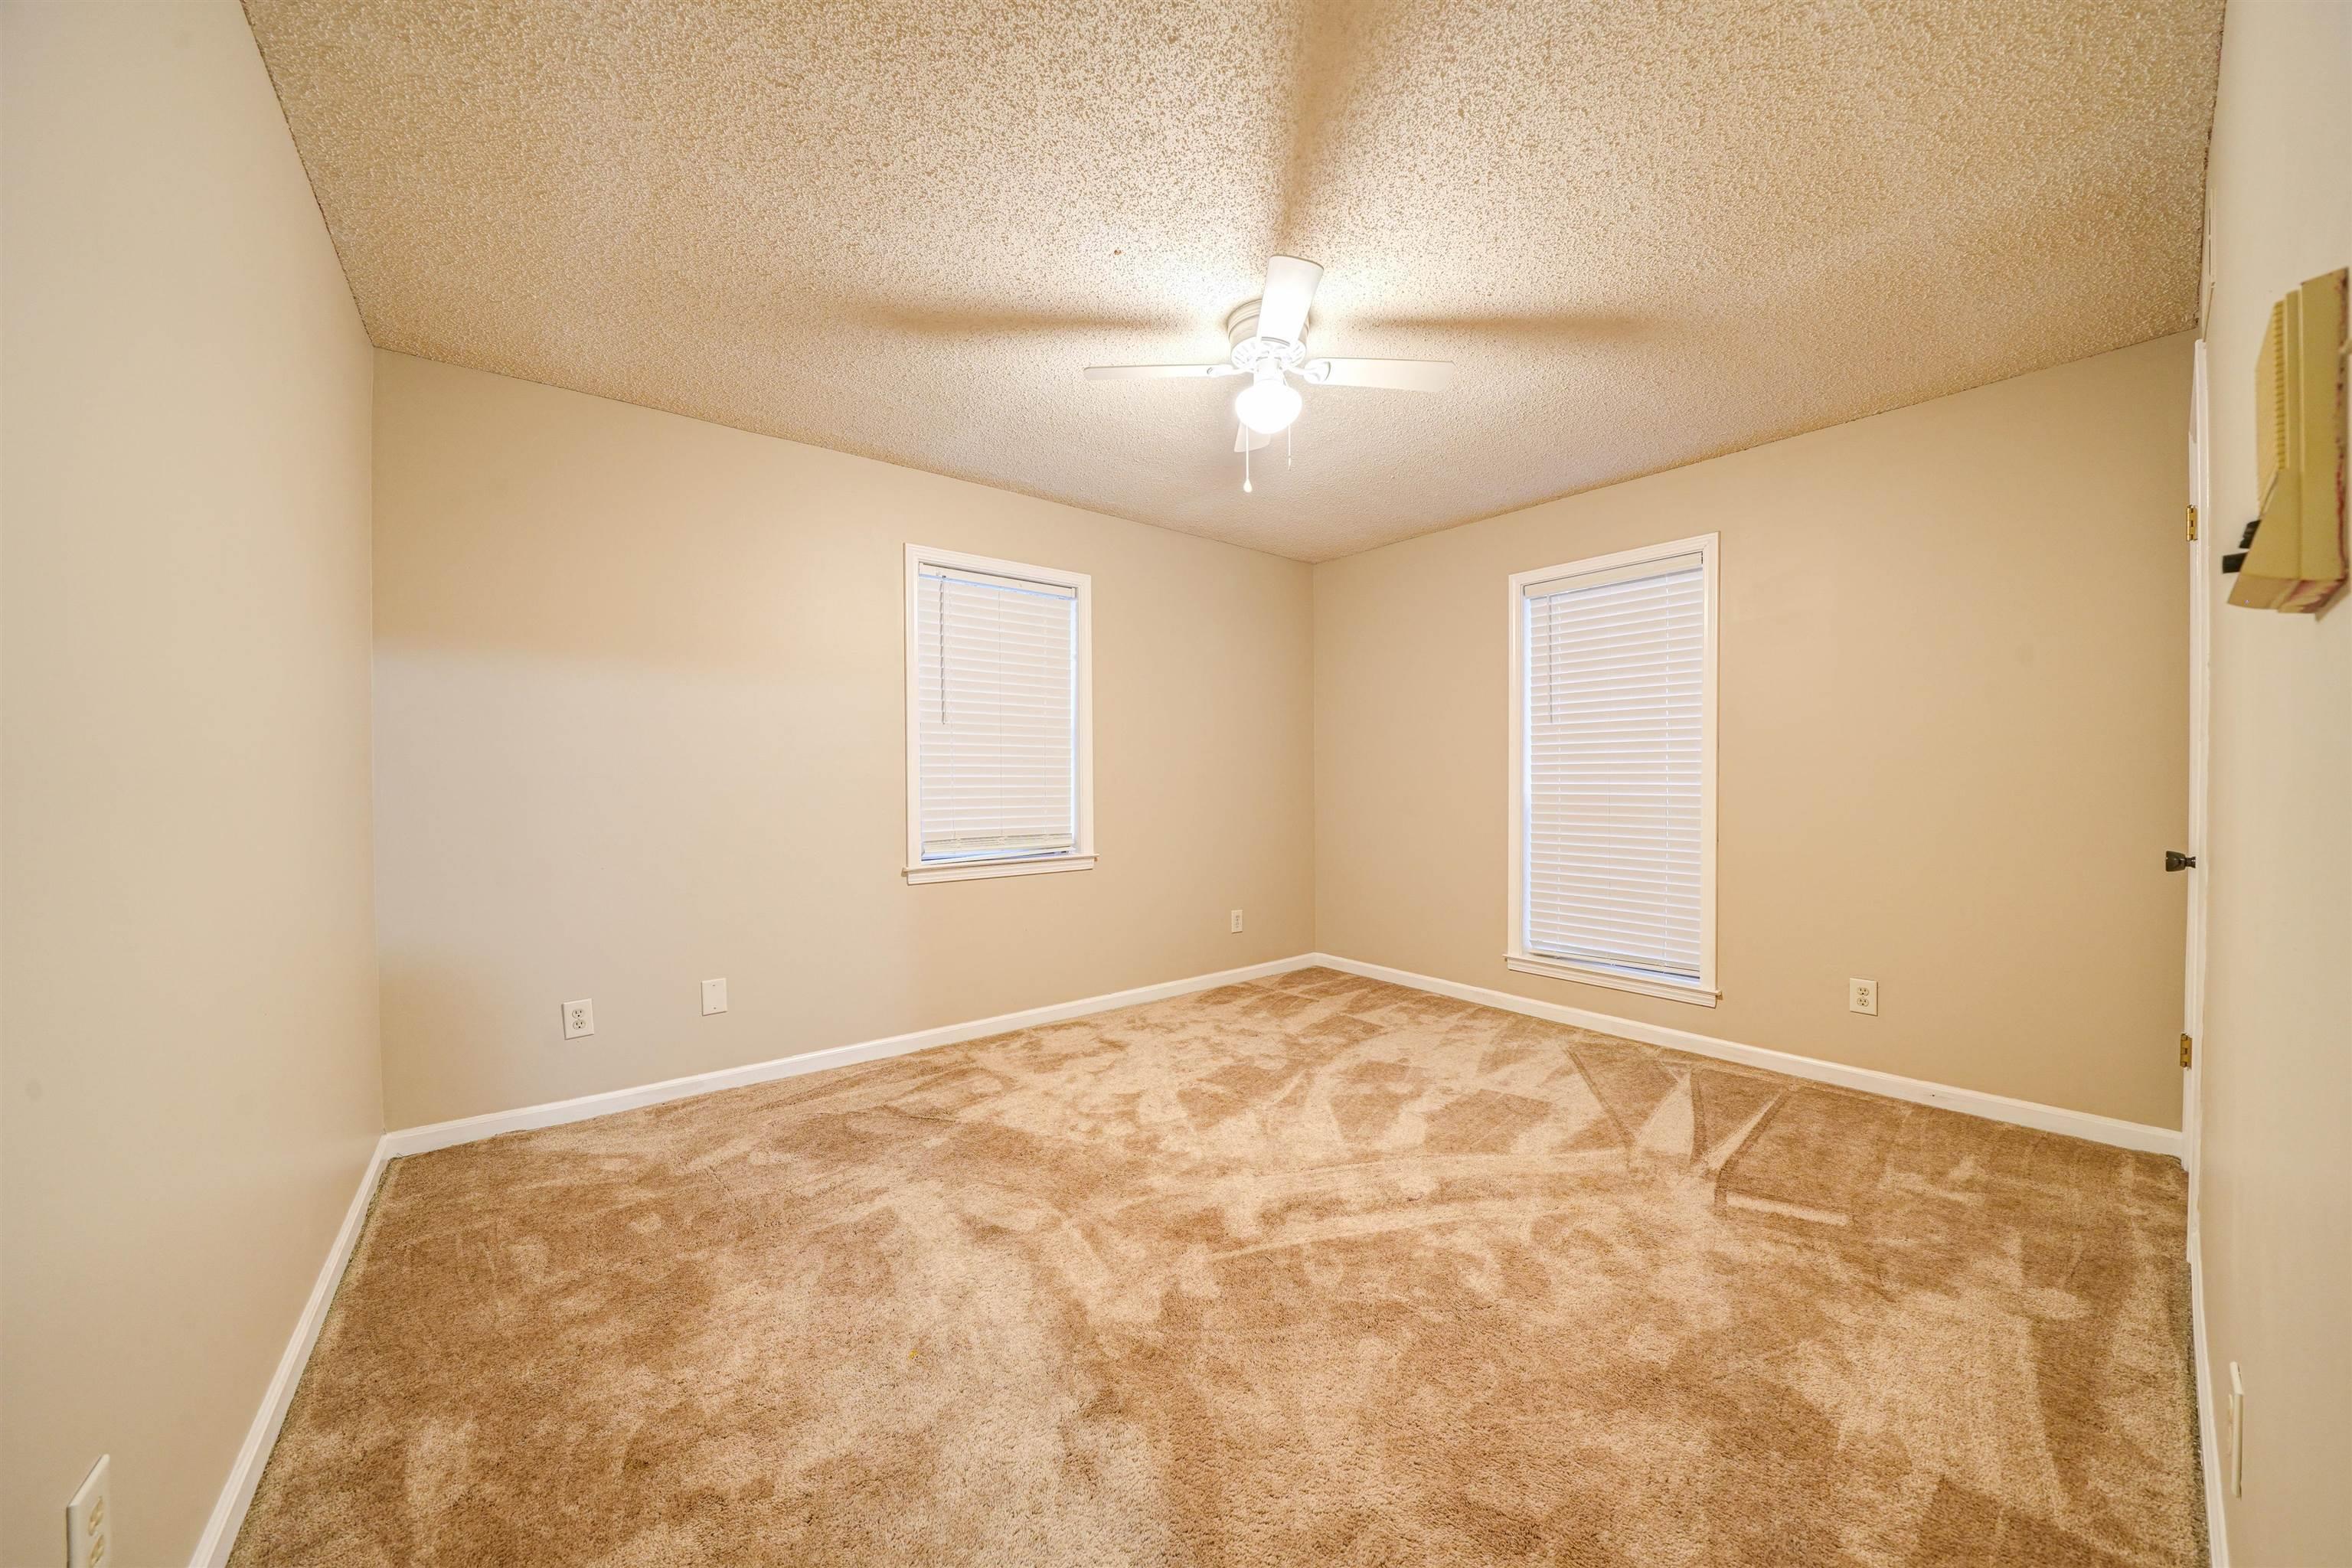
[247,0,2220,560]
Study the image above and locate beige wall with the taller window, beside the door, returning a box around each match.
[1315,338,2190,1126]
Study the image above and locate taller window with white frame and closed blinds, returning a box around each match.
[1503,534,1717,1006]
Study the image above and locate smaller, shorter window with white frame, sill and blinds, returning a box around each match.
[906,545,1093,881]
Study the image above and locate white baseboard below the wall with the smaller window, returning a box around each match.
[384,955,1317,1159]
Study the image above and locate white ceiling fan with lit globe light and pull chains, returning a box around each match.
[1086,256,1453,489]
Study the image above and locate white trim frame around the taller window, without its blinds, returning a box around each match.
[1503,534,1722,1006]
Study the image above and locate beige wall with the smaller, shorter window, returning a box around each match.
[377,355,1315,1126]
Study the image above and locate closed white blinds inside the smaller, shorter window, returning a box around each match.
[913,562,1077,863]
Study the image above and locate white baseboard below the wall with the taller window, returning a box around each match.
[1310,952,2180,1159]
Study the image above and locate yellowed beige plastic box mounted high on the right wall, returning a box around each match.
[2230,270,2347,611]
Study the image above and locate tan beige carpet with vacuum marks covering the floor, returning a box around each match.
[233,969,2203,1568]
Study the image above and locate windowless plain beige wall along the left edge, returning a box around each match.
[0,0,381,1568]
